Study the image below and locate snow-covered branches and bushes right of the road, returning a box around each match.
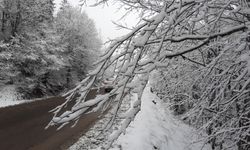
[50,0,250,150]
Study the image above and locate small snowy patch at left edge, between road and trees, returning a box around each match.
[0,85,25,107]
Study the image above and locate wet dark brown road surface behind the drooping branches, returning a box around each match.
[0,89,109,150]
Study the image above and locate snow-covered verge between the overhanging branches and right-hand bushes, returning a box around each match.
[69,84,210,150]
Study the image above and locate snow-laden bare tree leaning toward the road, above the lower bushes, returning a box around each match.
[49,0,249,149]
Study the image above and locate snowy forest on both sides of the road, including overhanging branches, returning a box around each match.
[0,0,250,150]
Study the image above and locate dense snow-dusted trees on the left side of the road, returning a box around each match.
[0,0,102,99]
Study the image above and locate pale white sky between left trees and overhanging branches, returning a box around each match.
[55,0,136,42]
